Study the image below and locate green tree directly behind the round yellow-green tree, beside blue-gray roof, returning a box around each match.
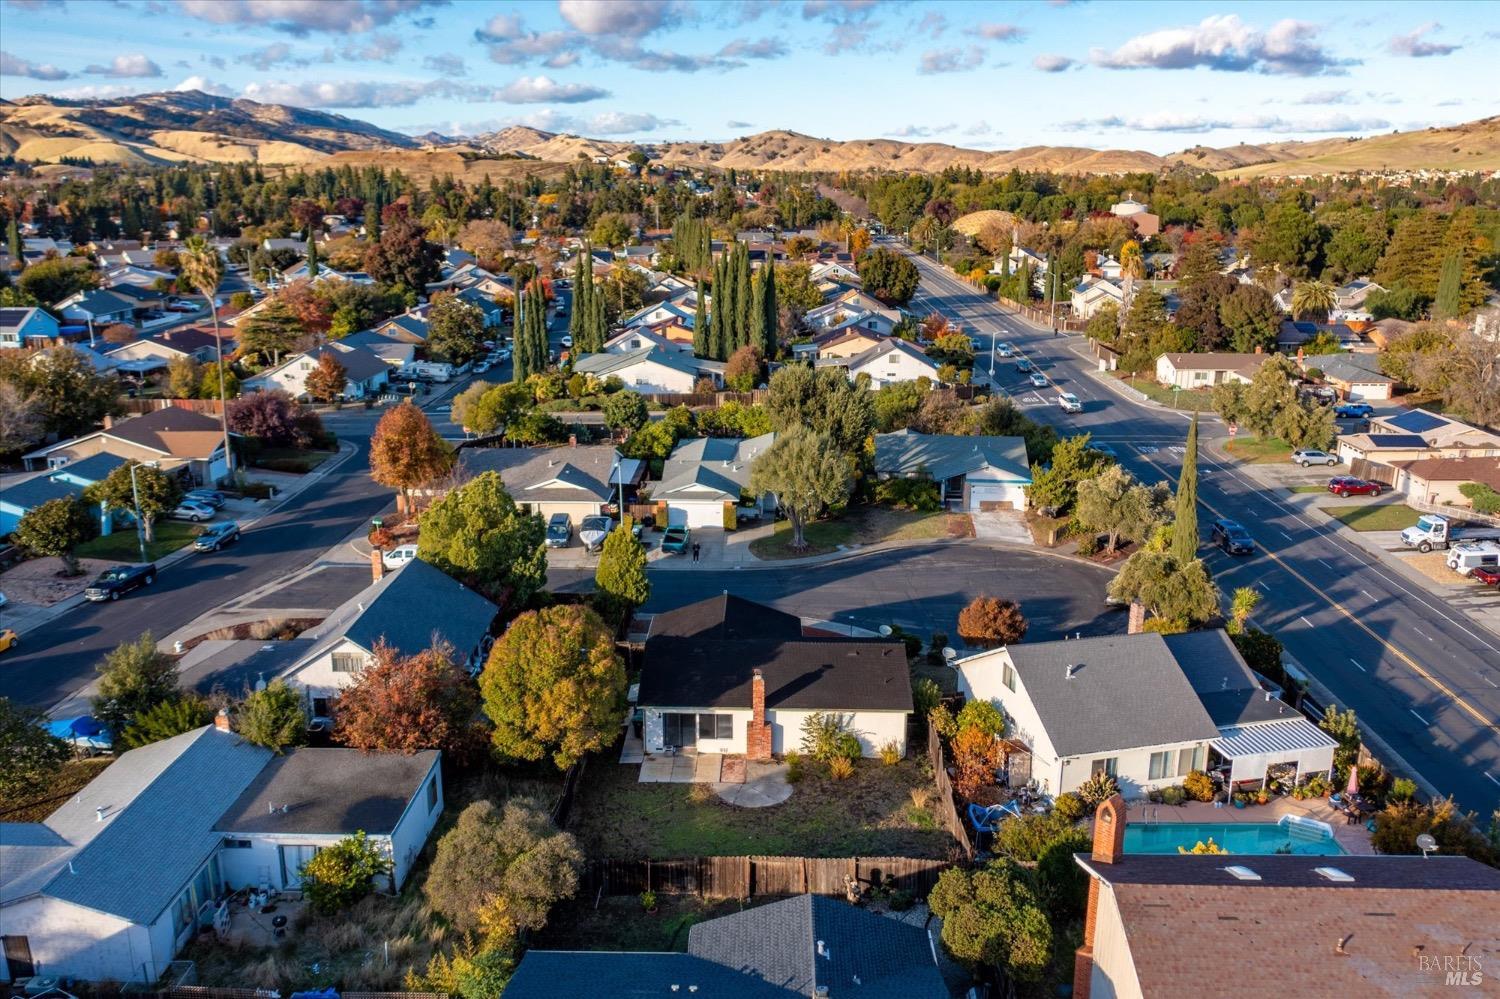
[417,471,548,608]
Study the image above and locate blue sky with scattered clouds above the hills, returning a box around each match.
[0,0,1500,153]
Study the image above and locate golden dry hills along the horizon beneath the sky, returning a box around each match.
[0,90,1500,176]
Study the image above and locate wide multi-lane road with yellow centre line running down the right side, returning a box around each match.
[914,243,1500,819]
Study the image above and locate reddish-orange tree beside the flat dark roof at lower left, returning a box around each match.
[332,642,479,755]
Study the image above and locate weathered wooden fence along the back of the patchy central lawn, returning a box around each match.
[579,857,953,899]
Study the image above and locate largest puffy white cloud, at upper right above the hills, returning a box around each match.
[1091,14,1359,77]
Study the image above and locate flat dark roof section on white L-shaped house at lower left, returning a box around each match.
[215,749,438,836]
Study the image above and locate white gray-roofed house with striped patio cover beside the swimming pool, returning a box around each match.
[954,632,1334,798]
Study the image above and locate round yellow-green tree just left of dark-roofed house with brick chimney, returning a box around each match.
[479,606,626,770]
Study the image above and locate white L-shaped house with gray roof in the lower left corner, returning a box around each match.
[0,716,443,983]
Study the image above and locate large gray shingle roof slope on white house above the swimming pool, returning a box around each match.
[1007,633,1218,756]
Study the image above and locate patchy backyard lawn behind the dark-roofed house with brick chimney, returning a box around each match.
[569,756,954,860]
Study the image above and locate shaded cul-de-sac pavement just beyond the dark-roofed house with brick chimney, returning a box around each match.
[548,545,1125,641]
